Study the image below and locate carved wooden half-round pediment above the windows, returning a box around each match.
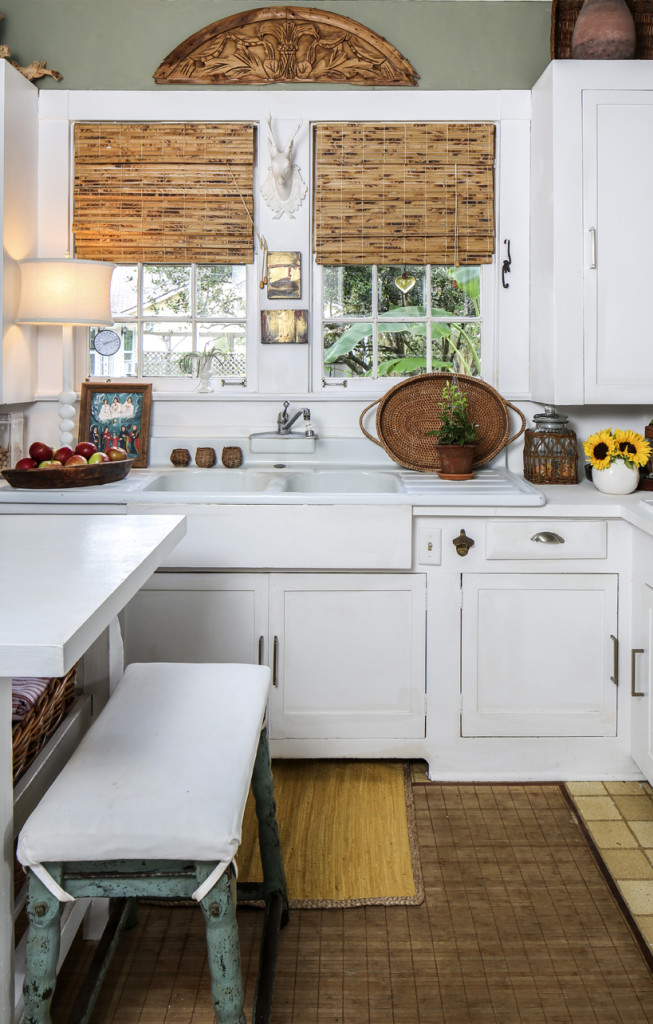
[154,7,418,86]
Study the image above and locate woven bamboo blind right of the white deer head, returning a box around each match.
[313,122,494,266]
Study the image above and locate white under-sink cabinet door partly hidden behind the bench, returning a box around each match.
[124,572,267,665]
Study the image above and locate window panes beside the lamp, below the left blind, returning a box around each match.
[89,263,247,379]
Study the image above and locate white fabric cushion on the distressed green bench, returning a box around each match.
[17,663,270,899]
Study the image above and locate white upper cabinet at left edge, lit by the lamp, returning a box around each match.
[0,60,39,404]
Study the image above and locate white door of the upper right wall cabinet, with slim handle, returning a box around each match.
[582,90,653,403]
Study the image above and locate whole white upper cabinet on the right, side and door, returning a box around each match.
[531,60,653,406]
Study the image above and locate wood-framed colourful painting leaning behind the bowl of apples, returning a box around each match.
[79,381,151,468]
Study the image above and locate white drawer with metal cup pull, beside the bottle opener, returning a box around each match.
[485,519,608,560]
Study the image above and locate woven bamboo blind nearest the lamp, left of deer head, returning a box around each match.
[73,123,255,263]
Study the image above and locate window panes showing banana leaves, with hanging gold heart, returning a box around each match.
[321,265,482,380]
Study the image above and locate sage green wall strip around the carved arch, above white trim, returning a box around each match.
[0,0,551,91]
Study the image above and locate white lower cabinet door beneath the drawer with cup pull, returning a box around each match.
[462,573,617,736]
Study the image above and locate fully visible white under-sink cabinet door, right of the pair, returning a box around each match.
[270,572,426,739]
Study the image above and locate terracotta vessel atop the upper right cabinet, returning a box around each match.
[571,0,637,60]
